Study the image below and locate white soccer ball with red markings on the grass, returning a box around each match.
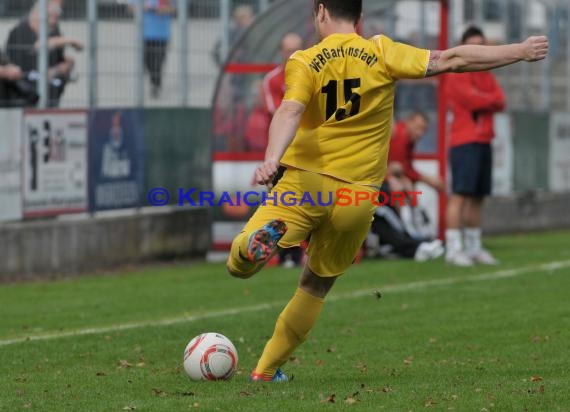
[184,332,238,381]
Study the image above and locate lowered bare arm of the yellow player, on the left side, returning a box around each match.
[255,100,305,189]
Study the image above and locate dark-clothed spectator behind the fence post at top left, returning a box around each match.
[6,0,83,107]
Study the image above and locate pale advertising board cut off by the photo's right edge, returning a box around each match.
[548,113,570,192]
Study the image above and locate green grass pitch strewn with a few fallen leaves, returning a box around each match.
[0,232,570,412]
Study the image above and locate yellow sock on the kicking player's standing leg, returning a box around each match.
[255,288,324,377]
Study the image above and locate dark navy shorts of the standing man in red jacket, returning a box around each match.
[449,143,493,197]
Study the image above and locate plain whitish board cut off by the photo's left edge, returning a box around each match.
[0,110,22,221]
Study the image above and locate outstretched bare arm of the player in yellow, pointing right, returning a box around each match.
[426,36,548,77]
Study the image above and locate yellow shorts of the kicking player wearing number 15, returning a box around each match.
[243,168,378,277]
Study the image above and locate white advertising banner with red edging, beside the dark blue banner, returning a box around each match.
[23,110,88,217]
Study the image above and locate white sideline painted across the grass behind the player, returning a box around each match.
[0,260,570,347]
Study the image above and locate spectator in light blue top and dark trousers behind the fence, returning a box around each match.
[130,0,176,99]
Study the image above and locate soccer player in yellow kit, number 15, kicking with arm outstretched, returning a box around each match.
[227,0,548,381]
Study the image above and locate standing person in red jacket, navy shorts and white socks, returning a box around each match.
[445,27,505,266]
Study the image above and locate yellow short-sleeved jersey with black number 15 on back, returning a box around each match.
[281,33,429,186]
